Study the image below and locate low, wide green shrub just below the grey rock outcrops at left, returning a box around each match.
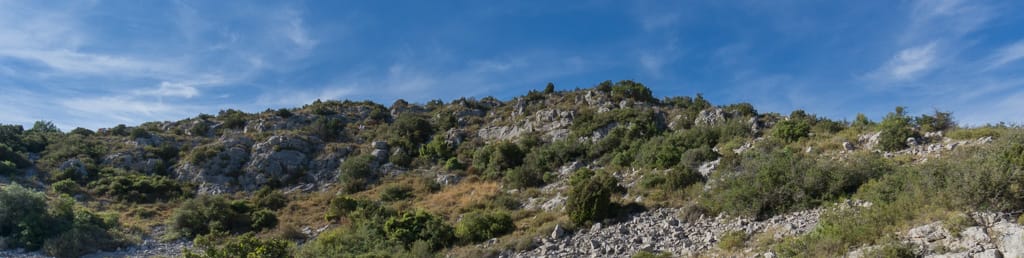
[88,172,191,203]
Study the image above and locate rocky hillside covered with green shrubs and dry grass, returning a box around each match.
[0,81,1024,257]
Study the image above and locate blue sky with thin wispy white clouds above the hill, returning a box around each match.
[0,0,1024,130]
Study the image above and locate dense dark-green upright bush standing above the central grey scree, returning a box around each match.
[565,169,621,225]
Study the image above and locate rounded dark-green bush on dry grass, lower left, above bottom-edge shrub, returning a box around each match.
[168,196,252,238]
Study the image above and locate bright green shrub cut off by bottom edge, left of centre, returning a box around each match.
[184,232,293,258]
